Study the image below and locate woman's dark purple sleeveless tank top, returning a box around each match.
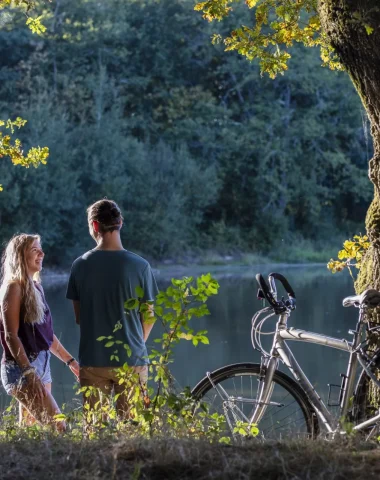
[0,282,54,362]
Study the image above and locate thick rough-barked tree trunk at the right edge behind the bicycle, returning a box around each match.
[318,0,380,406]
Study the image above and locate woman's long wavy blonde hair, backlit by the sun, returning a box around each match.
[0,233,45,324]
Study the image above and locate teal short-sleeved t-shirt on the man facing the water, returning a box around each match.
[66,250,158,367]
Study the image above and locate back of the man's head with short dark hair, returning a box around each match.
[87,198,123,241]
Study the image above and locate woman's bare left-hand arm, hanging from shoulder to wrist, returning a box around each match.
[1,282,30,370]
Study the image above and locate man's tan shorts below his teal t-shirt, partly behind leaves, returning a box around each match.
[79,365,148,394]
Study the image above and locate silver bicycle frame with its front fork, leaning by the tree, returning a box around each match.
[250,309,380,433]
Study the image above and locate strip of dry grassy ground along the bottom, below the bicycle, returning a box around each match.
[0,437,380,480]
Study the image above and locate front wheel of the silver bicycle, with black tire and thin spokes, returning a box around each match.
[192,363,319,440]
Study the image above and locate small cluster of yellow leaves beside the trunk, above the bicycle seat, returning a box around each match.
[327,235,370,276]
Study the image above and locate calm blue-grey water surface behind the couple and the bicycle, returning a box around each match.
[0,265,357,407]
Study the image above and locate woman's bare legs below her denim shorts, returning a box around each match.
[12,383,66,432]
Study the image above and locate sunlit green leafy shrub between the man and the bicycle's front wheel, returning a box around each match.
[81,274,235,440]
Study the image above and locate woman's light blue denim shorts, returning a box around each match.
[1,350,51,395]
